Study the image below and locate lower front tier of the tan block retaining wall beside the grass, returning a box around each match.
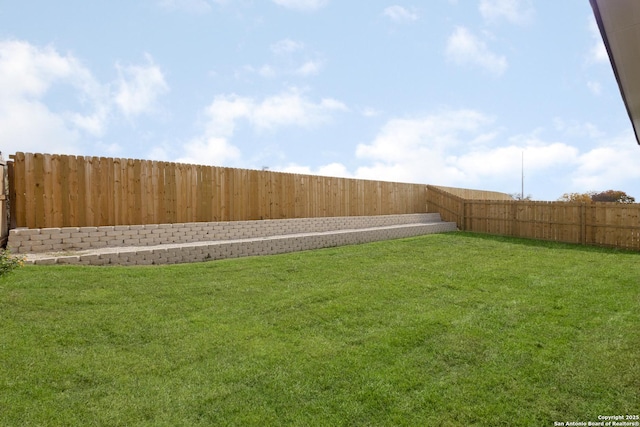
[25,216,457,265]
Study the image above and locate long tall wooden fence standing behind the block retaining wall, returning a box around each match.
[9,153,426,228]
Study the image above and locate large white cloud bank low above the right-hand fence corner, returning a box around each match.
[278,110,640,200]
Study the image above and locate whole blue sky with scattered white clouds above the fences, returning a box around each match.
[0,0,640,200]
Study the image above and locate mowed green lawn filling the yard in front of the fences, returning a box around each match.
[0,233,640,426]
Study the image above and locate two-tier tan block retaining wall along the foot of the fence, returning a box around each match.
[8,213,457,265]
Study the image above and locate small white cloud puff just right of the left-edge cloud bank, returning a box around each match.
[115,55,169,117]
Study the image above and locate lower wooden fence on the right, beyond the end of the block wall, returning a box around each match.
[427,185,640,250]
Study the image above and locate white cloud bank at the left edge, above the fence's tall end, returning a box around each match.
[0,40,168,154]
